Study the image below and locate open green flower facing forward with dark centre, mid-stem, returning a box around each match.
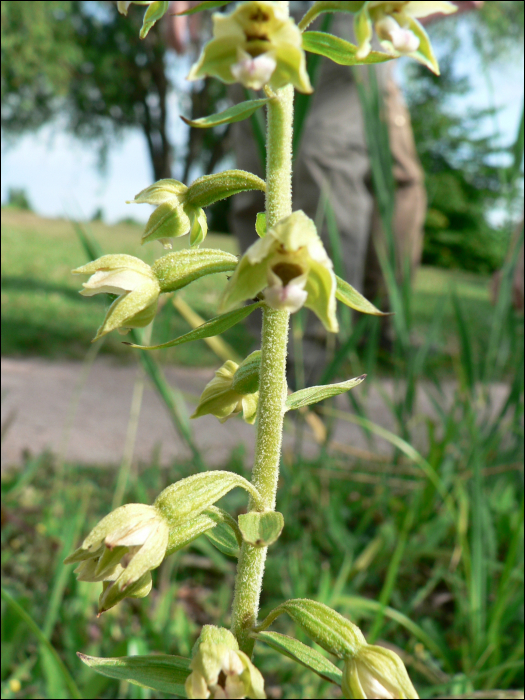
[222,211,339,333]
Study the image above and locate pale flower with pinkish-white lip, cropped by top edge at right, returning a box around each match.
[354,2,457,74]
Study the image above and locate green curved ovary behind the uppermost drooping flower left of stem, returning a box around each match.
[185,170,266,207]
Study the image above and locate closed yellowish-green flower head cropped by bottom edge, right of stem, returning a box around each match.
[342,644,419,698]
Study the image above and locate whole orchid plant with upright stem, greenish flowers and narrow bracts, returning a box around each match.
[66,0,455,698]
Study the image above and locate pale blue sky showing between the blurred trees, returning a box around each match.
[1,17,524,223]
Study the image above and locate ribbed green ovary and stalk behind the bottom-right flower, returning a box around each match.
[255,598,367,658]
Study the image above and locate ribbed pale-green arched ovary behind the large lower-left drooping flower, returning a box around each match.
[154,471,261,529]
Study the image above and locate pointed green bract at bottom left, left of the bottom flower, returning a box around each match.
[77,652,191,697]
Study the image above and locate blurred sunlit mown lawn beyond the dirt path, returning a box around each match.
[2,209,508,365]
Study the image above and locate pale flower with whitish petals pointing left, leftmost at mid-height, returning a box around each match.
[73,255,160,340]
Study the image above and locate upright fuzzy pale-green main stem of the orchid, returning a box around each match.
[232,21,294,655]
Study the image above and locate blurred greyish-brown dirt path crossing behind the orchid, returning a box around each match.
[1,357,507,468]
